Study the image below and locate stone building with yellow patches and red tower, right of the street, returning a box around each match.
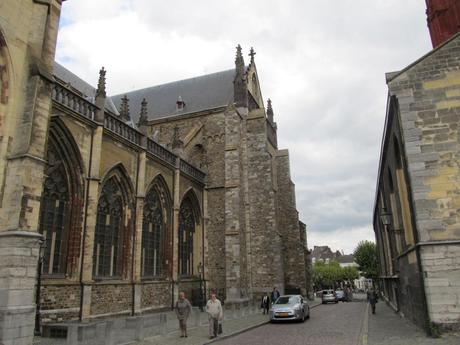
[373,0,460,330]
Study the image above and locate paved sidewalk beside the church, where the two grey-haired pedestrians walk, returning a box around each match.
[136,300,321,345]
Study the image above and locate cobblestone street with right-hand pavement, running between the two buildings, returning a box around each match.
[215,301,460,345]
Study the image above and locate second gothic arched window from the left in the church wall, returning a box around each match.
[93,177,123,277]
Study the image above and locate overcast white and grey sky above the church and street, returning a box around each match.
[56,0,431,253]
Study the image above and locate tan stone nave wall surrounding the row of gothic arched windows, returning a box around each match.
[31,105,204,323]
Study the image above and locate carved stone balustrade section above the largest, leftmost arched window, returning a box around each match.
[51,82,97,120]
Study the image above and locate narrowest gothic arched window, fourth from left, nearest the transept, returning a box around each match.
[179,198,196,276]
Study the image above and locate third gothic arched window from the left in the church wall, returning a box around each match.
[141,187,165,277]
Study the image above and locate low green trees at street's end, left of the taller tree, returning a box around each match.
[313,261,359,288]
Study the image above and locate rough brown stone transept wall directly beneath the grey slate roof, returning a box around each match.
[150,111,226,291]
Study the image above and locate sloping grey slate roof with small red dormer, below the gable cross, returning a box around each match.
[112,69,235,123]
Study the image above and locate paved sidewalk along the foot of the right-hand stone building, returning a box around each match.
[361,301,460,345]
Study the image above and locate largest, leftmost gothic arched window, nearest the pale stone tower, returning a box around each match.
[40,141,70,274]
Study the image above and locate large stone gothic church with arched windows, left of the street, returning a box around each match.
[0,0,310,344]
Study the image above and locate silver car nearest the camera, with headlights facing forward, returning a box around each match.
[270,295,310,322]
